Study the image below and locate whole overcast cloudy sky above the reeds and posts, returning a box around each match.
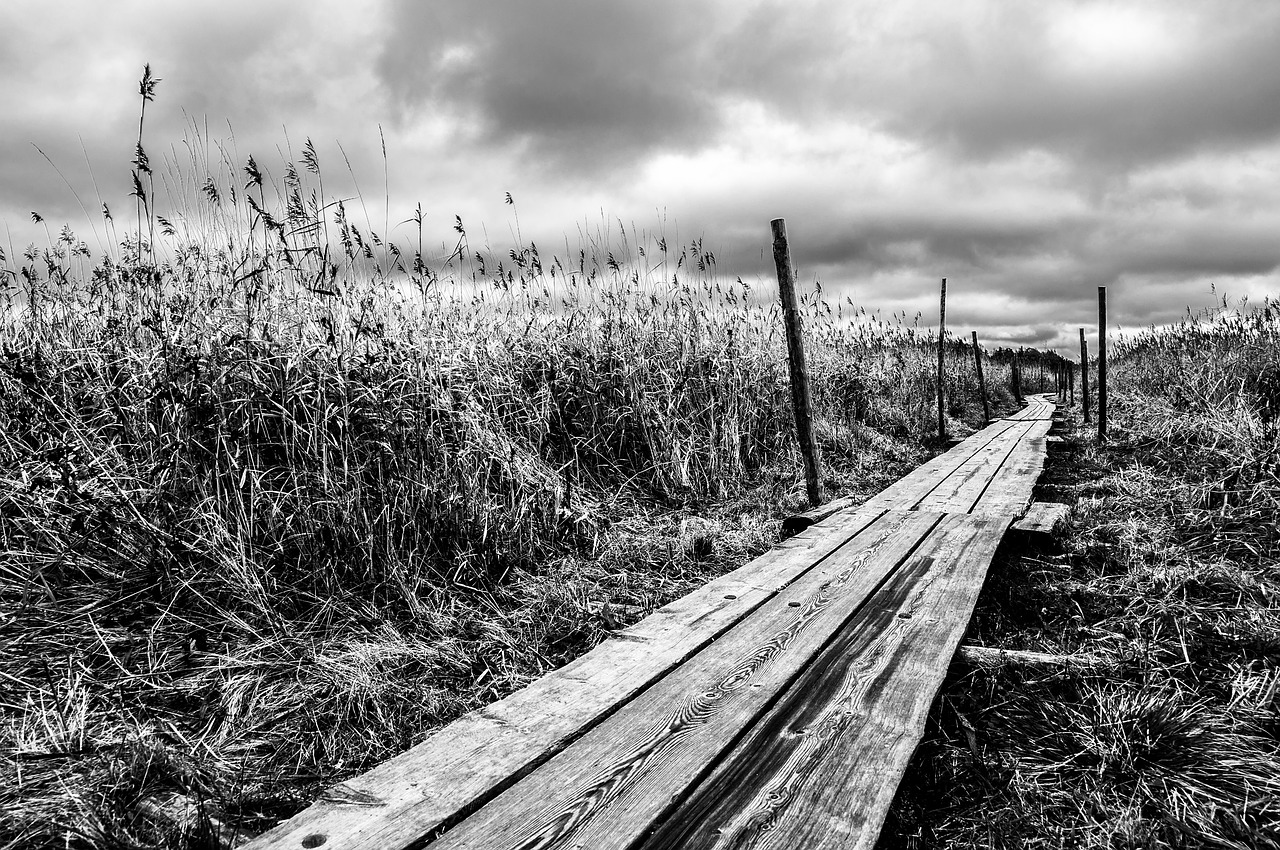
[0,0,1280,349]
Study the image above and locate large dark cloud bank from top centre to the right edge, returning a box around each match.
[378,0,1280,179]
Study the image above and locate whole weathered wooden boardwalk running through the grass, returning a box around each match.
[247,397,1053,850]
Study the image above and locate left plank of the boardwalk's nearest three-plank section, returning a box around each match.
[244,509,882,850]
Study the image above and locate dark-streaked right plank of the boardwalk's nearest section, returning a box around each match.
[632,515,1009,850]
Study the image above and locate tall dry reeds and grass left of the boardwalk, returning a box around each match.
[0,74,1039,849]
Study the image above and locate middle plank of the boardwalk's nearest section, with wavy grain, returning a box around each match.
[419,512,955,850]
